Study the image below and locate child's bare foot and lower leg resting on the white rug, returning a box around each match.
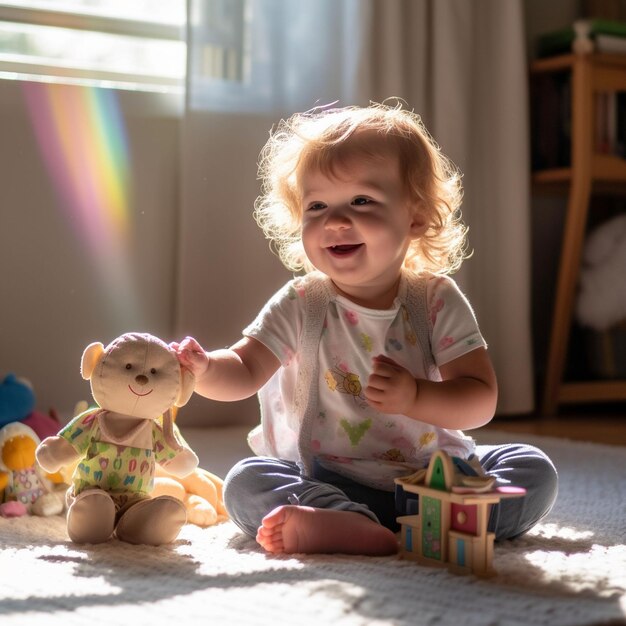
[256,505,398,556]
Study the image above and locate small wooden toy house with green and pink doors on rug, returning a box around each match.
[395,450,525,576]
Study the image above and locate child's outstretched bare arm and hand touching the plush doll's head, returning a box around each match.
[172,337,280,401]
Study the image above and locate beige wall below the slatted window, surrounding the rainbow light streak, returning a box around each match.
[0,80,180,417]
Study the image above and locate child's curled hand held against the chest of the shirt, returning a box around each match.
[364,355,418,415]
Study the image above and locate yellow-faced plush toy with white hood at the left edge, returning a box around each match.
[0,422,64,517]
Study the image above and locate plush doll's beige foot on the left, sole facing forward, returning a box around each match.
[67,489,115,543]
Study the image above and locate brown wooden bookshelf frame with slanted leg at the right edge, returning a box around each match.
[530,54,626,415]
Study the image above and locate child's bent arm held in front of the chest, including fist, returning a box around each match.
[364,348,498,430]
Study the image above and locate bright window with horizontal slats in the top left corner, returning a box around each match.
[0,0,187,93]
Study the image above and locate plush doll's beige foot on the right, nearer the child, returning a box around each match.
[115,496,187,546]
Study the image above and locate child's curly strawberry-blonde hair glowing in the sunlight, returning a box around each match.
[254,104,467,274]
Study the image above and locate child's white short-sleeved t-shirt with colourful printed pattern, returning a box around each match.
[244,276,485,490]
